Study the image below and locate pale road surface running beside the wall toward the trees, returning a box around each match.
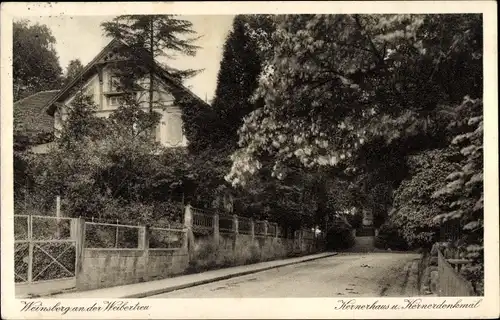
[148,252,419,298]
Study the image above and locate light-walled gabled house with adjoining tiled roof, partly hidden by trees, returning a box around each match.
[14,39,208,153]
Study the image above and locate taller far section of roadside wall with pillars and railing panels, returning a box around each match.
[184,205,319,272]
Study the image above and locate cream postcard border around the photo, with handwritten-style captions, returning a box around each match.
[0,1,500,319]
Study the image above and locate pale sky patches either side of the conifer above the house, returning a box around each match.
[20,15,234,101]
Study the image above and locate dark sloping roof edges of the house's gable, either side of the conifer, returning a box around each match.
[45,39,208,116]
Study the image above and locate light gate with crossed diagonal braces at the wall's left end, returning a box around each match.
[14,215,78,297]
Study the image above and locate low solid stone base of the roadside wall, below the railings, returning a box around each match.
[77,233,316,290]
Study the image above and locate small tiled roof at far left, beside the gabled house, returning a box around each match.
[13,90,59,134]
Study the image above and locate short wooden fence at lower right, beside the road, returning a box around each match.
[438,250,476,297]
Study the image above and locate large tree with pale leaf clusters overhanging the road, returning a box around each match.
[227,15,482,184]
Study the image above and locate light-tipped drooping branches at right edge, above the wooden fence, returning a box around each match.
[432,97,484,294]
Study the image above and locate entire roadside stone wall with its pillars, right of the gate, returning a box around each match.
[71,206,318,290]
